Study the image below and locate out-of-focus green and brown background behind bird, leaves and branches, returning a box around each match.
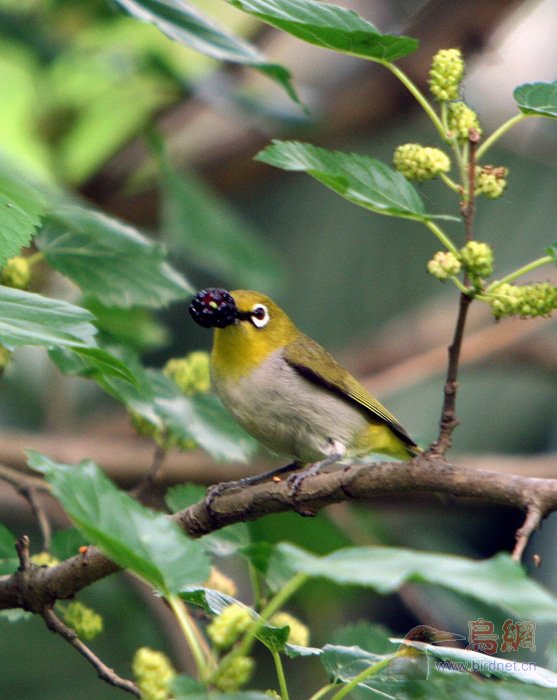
[0,0,557,700]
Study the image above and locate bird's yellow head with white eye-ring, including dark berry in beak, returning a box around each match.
[189,288,299,376]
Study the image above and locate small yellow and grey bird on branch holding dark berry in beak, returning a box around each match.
[190,288,421,491]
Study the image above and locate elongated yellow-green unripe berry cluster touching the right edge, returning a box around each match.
[490,282,557,318]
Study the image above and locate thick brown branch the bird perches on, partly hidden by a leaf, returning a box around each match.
[0,453,557,614]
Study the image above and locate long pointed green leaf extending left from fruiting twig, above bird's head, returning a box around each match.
[256,141,452,221]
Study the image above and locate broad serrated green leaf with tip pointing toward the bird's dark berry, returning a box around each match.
[36,206,192,308]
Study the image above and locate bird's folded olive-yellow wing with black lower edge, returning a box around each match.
[284,336,416,447]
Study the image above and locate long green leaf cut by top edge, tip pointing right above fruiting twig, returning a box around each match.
[228,0,418,62]
